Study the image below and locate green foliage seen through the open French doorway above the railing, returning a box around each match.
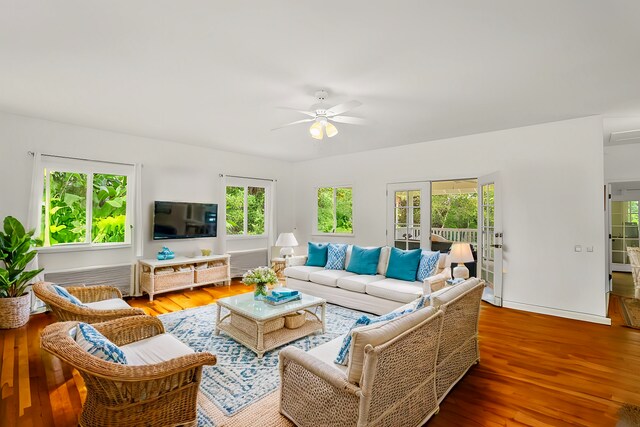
[431,193,478,228]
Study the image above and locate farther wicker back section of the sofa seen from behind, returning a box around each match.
[432,277,484,403]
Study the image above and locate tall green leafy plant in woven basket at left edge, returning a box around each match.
[0,216,43,329]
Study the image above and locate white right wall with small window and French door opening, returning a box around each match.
[295,117,607,323]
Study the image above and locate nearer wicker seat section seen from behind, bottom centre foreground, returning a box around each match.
[279,307,442,427]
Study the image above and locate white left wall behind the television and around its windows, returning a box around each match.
[0,113,294,270]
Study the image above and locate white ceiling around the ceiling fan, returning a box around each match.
[0,0,640,160]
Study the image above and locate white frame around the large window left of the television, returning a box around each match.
[32,155,135,253]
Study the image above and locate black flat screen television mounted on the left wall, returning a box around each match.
[153,201,218,240]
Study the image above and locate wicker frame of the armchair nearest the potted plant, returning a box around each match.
[33,282,145,323]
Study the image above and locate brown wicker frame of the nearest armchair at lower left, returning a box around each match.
[41,316,216,427]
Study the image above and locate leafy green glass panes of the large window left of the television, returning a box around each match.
[41,170,127,246]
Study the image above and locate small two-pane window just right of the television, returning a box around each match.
[226,185,266,236]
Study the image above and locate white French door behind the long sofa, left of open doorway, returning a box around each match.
[387,181,431,250]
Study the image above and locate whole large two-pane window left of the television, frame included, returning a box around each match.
[38,156,133,251]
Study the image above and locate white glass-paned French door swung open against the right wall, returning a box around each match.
[478,173,503,307]
